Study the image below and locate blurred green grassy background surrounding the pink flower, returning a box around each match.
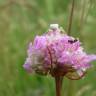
[0,0,96,96]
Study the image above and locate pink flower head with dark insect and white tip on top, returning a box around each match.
[24,24,96,79]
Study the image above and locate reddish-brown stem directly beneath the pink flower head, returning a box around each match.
[55,76,63,96]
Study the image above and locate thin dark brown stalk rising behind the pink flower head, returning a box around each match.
[67,0,75,35]
